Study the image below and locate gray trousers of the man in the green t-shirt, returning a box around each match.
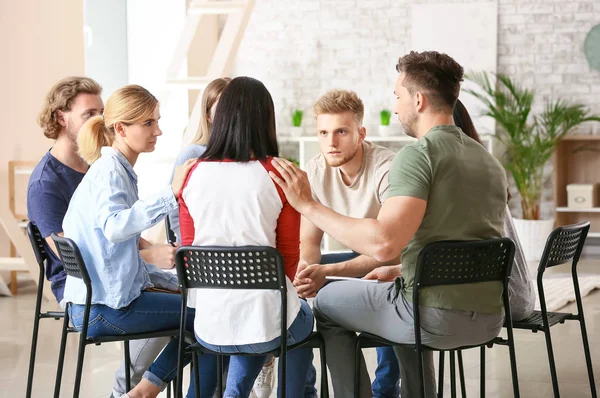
[314,278,504,398]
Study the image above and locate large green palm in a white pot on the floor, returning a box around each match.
[464,72,600,261]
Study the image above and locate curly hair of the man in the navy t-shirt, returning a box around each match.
[38,76,102,140]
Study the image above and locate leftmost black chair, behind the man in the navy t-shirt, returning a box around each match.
[25,222,72,398]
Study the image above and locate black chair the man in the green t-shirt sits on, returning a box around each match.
[354,238,519,397]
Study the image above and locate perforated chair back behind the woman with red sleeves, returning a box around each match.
[175,246,286,294]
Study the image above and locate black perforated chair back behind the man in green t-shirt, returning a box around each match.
[415,238,515,288]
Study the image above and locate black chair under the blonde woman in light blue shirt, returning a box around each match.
[52,234,179,398]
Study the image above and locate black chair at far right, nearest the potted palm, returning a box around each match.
[513,221,598,398]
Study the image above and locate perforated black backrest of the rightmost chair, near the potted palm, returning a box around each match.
[539,221,590,272]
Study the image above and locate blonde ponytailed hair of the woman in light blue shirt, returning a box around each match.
[77,84,158,164]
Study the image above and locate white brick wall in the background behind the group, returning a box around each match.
[235,0,600,216]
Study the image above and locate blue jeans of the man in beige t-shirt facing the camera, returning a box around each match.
[304,252,400,398]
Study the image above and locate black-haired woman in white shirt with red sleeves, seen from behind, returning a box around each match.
[179,77,313,398]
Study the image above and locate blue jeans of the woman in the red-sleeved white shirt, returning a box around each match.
[196,300,314,398]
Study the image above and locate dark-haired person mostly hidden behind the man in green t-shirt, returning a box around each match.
[453,100,535,322]
